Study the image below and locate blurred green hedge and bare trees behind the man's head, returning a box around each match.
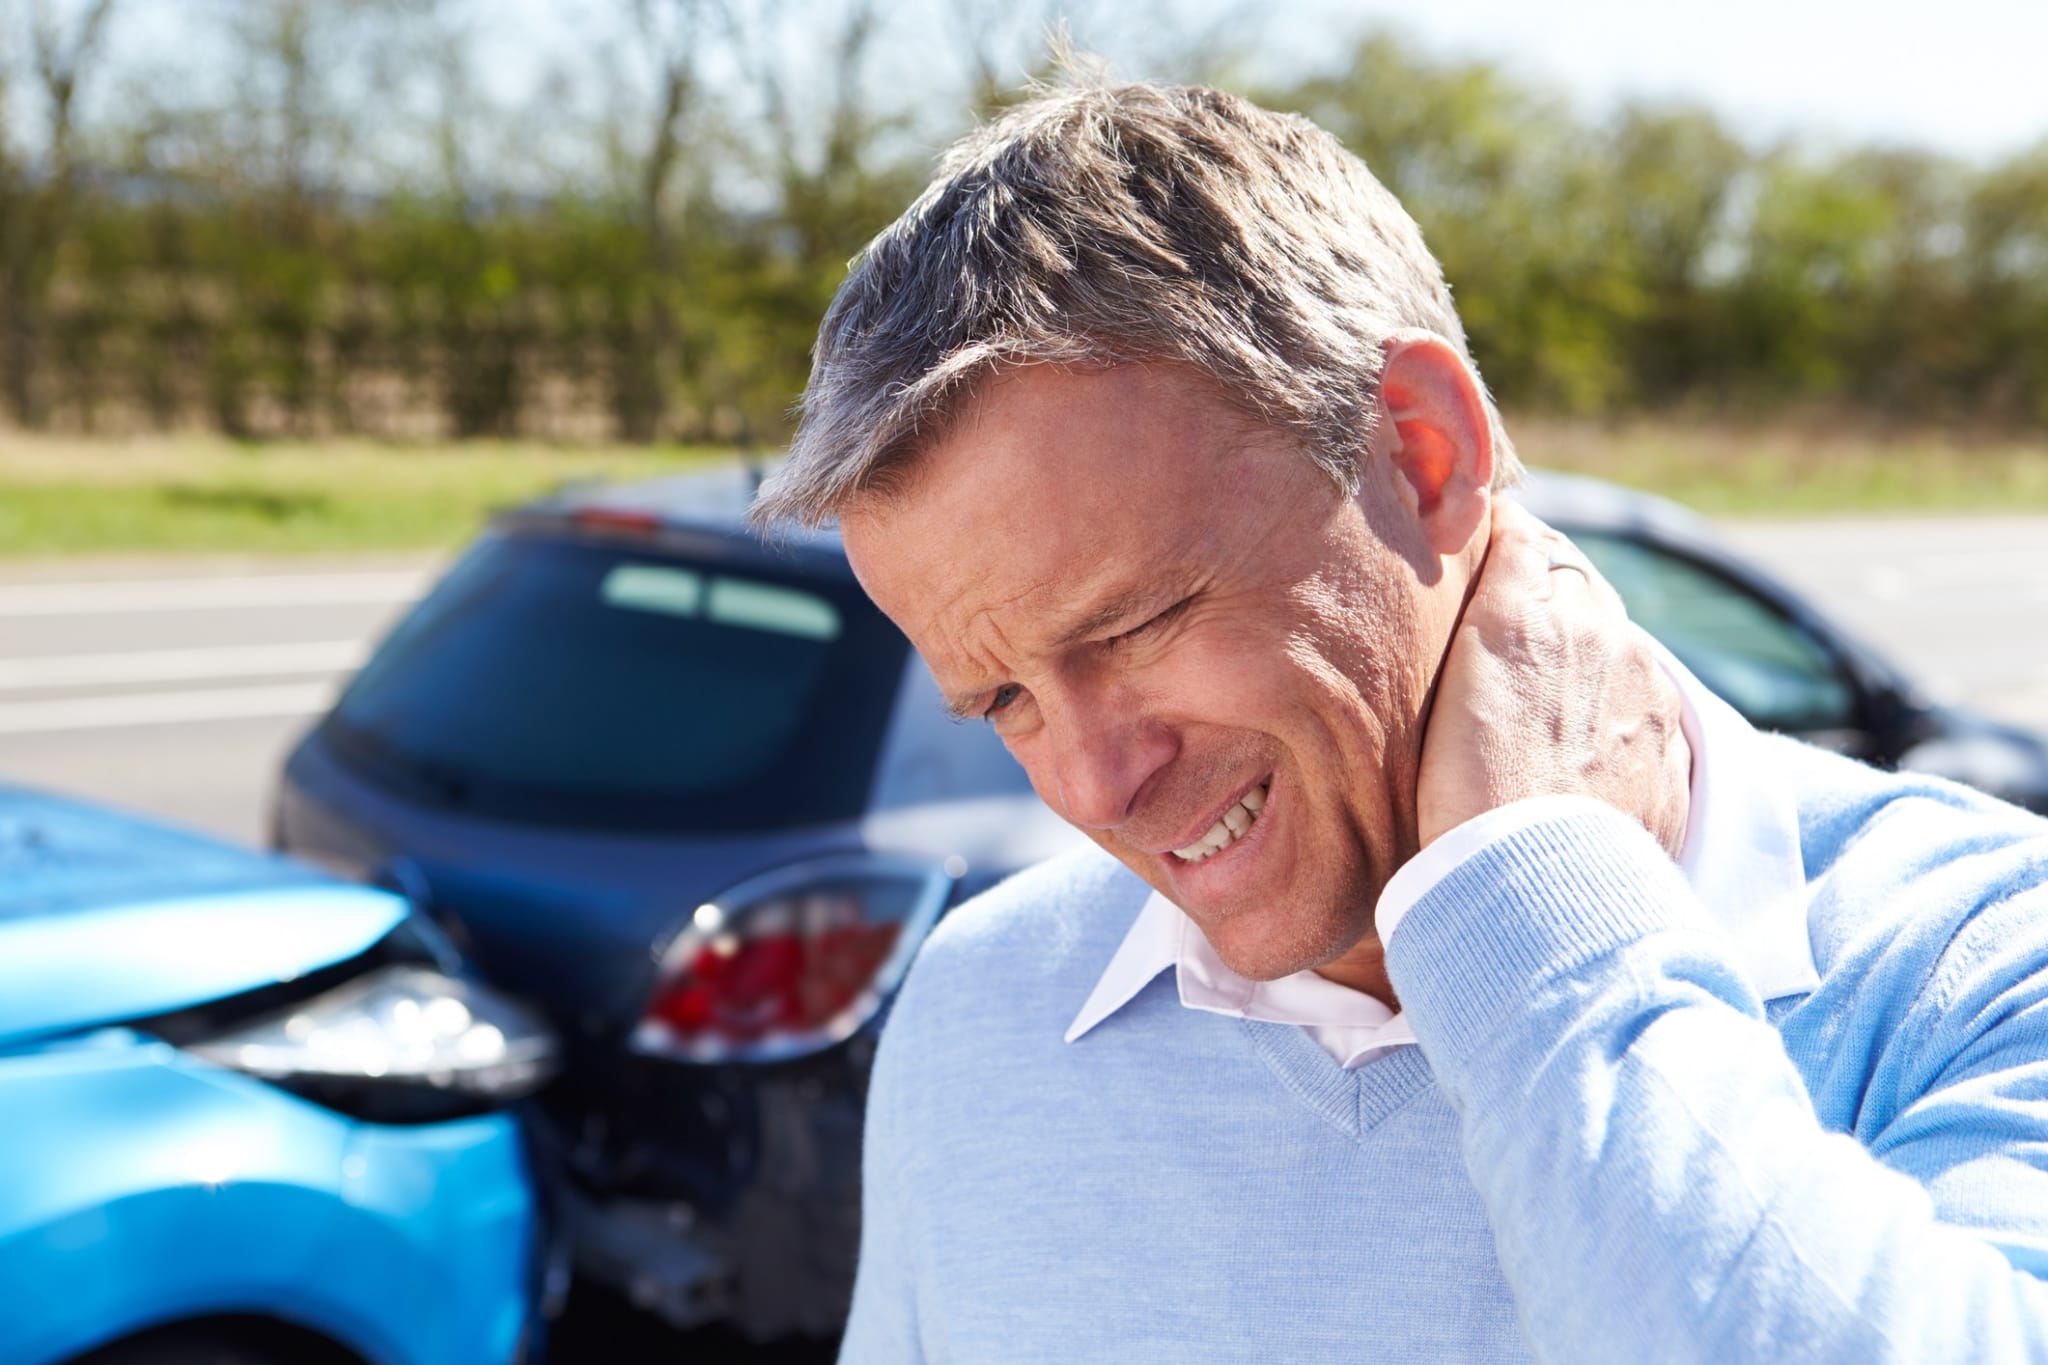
[0,0,2048,444]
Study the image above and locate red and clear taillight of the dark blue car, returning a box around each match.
[633,855,954,1062]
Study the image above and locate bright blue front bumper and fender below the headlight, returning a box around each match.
[0,1029,537,1365]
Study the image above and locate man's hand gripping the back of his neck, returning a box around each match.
[1415,499,1692,857]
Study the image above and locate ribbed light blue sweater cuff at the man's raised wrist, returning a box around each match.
[1386,798,1706,1056]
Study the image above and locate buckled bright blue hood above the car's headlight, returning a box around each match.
[0,788,408,1042]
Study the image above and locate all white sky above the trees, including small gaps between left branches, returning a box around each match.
[28,0,2048,162]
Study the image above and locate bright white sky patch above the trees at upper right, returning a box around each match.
[1272,0,2048,160]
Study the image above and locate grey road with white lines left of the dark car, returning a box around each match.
[0,557,434,841]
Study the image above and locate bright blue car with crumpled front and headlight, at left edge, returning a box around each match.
[0,786,557,1365]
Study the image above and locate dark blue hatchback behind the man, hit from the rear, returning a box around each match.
[274,469,2048,1338]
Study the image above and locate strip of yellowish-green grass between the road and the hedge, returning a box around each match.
[0,420,2048,559]
